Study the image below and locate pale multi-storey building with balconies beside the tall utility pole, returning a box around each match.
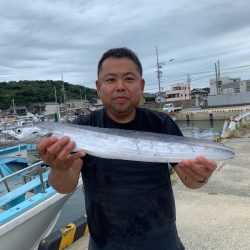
[165,83,191,102]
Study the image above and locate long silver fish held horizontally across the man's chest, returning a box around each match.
[2,122,234,162]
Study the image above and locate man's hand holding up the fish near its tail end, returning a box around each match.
[174,156,217,188]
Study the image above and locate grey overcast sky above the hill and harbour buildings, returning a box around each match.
[0,0,250,93]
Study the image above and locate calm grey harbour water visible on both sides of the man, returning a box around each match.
[53,120,224,231]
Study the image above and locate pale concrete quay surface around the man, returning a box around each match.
[67,137,250,250]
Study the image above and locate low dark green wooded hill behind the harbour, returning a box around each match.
[0,80,96,109]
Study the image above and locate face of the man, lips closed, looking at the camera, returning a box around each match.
[96,58,144,120]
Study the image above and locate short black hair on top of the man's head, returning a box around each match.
[97,47,142,76]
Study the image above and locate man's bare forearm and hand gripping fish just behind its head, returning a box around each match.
[37,137,86,193]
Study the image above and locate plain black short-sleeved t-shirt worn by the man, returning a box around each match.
[73,108,183,250]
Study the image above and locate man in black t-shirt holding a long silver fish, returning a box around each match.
[37,48,216,250]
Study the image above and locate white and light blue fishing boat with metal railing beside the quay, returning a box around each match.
[0,145,82,250]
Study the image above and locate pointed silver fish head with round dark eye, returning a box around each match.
[4,126,51,143]
